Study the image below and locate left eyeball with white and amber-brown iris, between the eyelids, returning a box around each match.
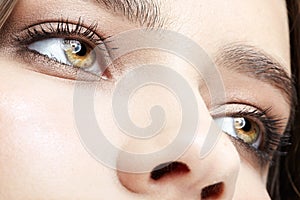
[28,38,107,78]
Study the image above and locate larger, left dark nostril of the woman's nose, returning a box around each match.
[151,162,190,180]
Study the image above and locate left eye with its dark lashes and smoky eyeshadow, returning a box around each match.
[13,17,112,81]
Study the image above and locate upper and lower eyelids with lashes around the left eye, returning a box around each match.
[15,18,118,82]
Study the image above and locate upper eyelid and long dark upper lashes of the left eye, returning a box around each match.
[12,17,113,81]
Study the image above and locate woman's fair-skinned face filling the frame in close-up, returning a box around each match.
[0,0,291,199]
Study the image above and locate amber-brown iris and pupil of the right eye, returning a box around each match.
[234,118,260,144]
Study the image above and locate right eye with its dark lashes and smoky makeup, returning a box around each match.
[213,103,290,168]
